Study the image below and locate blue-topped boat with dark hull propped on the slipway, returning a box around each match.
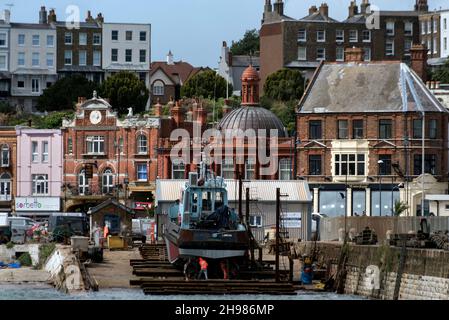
[164,164,249,263]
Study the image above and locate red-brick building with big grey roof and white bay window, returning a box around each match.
[297,46,448,216]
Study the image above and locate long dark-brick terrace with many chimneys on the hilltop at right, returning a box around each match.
[260,0,428,87]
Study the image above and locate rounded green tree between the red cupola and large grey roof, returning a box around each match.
[264,69,305,101]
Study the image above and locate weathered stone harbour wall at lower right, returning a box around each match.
[294,242,449,300]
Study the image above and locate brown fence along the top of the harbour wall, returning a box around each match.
[320,217,449,241]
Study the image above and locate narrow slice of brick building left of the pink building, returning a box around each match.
[0,127,17,212]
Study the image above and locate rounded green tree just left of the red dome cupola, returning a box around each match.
[181,70,233,99]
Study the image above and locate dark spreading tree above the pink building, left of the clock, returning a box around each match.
[37,75,96,111]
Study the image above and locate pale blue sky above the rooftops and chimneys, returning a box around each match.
[0,0,449,68]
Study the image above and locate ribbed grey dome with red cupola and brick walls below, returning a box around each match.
[213,66,295,180]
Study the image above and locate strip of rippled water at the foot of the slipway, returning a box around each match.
[0,285,363,300]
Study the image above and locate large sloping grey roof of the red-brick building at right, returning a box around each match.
[298,62,448,113]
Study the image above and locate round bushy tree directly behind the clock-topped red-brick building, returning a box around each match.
[99,71,150,115]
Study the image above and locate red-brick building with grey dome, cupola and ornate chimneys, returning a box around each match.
[155,66,295,180]
